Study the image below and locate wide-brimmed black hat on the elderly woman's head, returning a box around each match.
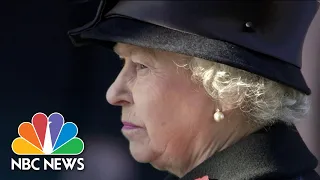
[69,0,318,95]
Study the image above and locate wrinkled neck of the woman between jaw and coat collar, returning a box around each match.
[167,112,261,178]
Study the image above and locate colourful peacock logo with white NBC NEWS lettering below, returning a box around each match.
[11,112,84,170]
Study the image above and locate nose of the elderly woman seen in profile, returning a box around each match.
[106,73,133,106]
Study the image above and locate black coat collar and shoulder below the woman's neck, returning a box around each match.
[165,123,320,180]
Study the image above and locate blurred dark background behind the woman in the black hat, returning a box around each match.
[0,0,320,180]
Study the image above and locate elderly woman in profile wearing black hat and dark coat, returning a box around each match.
[70,0,320,180]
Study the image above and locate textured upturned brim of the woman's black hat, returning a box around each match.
[69,16,311,95]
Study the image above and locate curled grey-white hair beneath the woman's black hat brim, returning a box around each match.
[176,57,310,125]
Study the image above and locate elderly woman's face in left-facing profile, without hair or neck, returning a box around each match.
[107,43,214,169]
